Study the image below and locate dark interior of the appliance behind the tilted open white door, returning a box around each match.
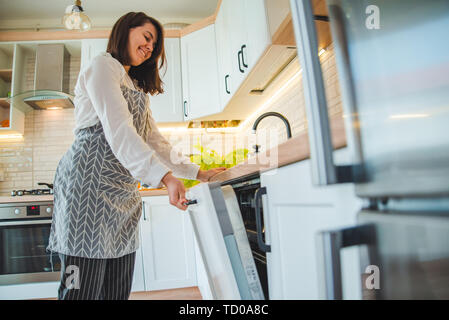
[226,174,269,300]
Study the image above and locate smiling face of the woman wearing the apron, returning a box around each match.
[128,22,157,67]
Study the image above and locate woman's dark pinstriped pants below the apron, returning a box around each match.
[58,252,136,300]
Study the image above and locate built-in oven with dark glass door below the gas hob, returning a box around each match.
[0,202,61,285]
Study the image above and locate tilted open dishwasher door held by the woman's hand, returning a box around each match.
[188,182,264,300]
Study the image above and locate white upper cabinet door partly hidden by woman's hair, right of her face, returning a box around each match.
[150,38,184,122]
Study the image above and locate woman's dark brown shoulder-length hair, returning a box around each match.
[106,12,167,95]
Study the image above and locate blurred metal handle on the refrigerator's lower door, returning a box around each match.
[316,224,379,300]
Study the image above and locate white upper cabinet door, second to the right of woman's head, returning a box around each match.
[181,24,221,120]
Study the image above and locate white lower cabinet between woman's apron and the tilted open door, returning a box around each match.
[140,196,197,291]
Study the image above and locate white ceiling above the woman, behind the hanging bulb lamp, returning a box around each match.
[0,0,218,30]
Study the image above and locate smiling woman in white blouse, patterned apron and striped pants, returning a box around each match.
[48,12,225,299]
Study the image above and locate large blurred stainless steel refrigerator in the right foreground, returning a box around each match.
[290,0,449,299]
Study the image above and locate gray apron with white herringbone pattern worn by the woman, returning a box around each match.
[47,85,150,259]
